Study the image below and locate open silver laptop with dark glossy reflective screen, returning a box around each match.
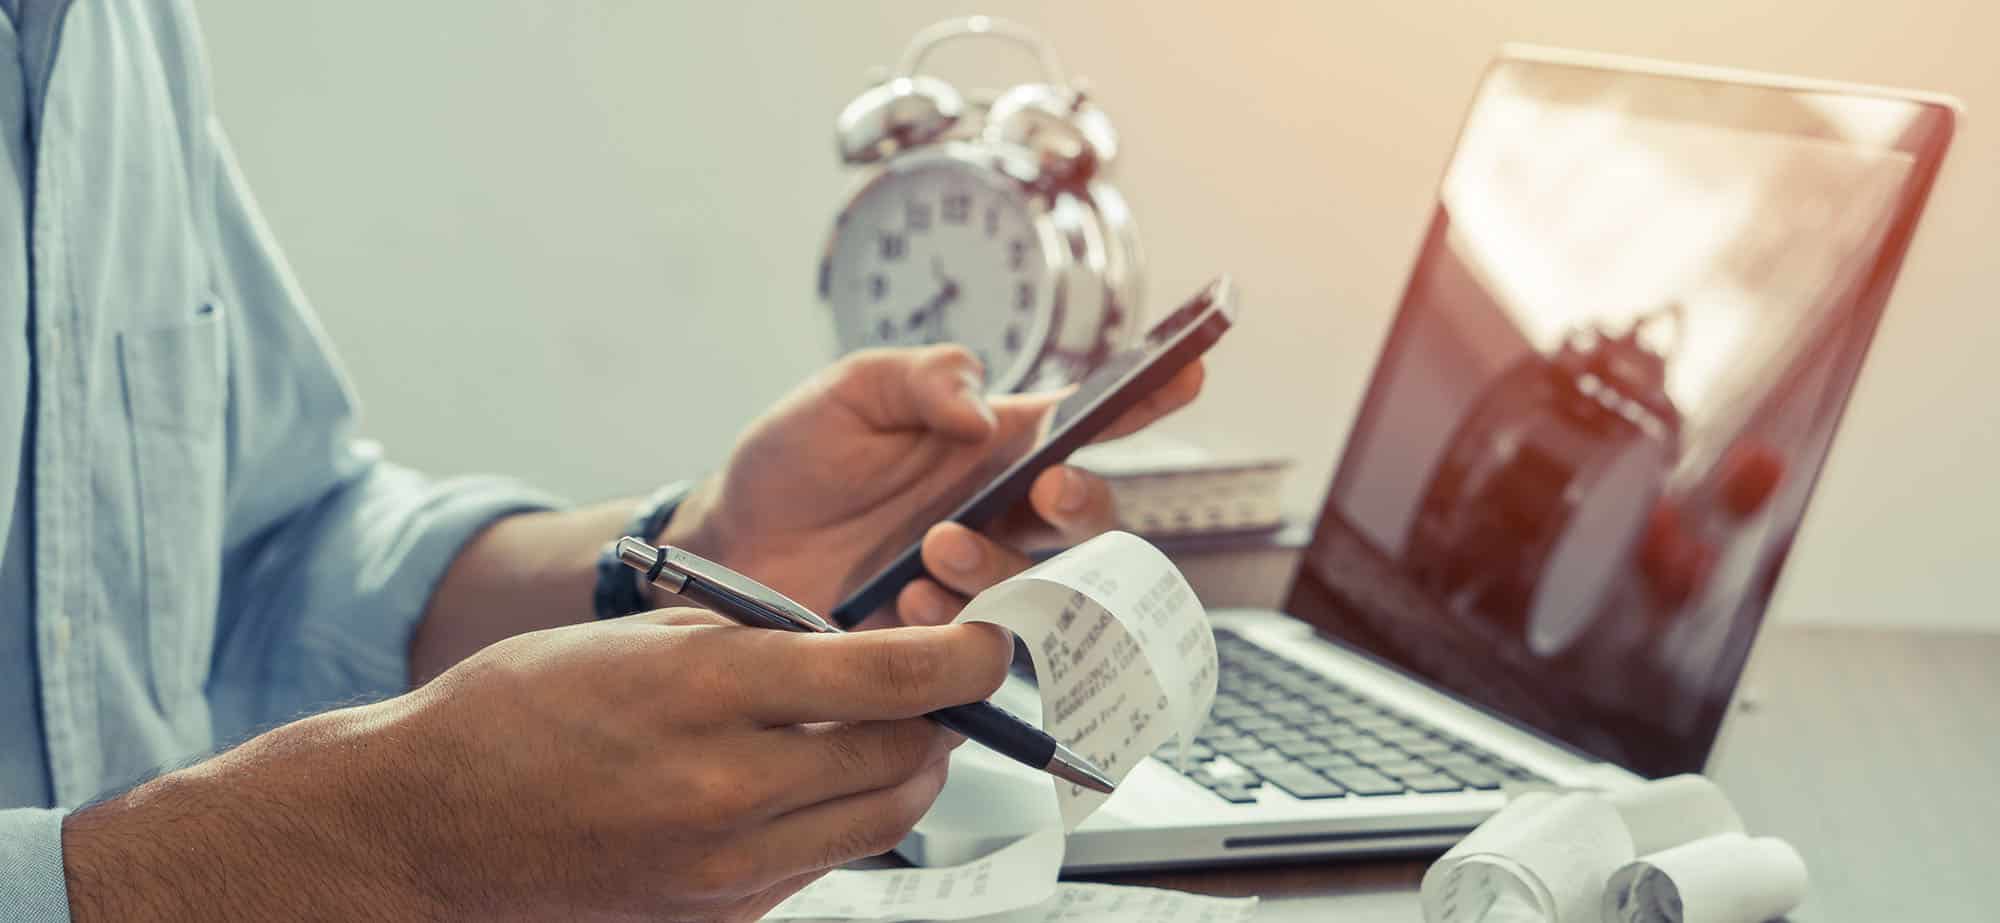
[900,48,1956,873]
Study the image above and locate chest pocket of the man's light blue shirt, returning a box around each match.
[118,304,228,711]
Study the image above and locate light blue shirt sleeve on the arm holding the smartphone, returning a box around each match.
[208,124,556,741]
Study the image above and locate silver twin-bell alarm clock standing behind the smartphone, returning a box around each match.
[820,16,1142,392]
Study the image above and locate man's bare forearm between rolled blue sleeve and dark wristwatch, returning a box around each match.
[410,489,708,685]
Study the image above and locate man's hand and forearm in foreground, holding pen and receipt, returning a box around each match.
[64,609,1010,923]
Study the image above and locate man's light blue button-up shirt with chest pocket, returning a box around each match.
[0,0,550,921]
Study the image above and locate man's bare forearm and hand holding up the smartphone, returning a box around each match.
[410,346,1202,685]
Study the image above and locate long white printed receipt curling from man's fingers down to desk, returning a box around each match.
[766,531,1232,923]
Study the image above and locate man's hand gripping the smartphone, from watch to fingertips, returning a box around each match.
[660,346,1202,625]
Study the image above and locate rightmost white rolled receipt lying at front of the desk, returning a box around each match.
[1604,833,1806,923]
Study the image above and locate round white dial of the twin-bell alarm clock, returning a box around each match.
[820,158,1056,392]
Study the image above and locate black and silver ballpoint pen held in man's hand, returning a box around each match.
[618,535,1114,793]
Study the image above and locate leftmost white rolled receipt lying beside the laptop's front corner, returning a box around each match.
[1422,791,1632,923]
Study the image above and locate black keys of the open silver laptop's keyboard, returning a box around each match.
[1156,629,1544,803]
